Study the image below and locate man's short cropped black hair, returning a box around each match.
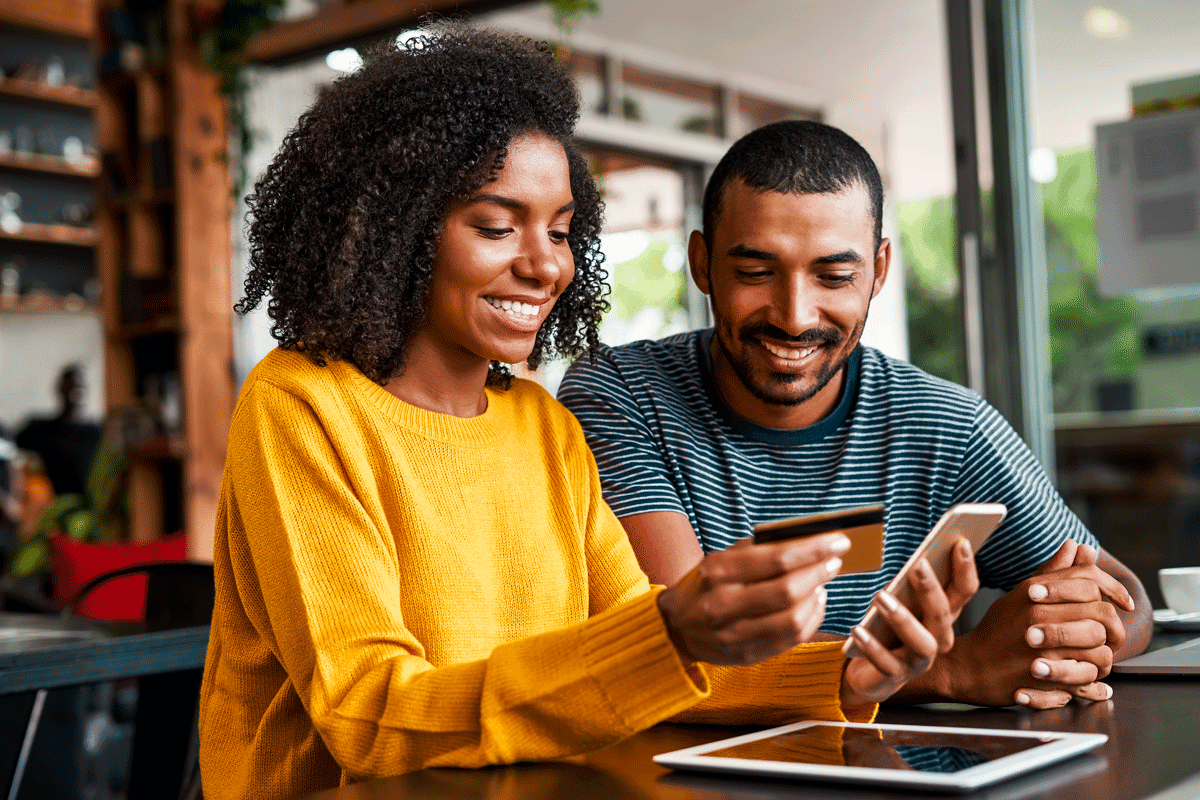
[703,120,883,249]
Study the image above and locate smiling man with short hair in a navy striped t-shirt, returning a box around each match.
[559,122,1152,708]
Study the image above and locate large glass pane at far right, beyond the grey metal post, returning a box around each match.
[1030,0,1200,606]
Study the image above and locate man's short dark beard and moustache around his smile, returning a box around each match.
[714,309,866,407]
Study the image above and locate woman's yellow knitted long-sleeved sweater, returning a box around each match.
[199,350,873,800]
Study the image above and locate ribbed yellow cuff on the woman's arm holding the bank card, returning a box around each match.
[583,587,709,732]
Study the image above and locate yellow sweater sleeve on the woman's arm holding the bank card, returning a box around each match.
[226,384,707,777]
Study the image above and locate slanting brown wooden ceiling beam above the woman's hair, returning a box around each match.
[241,0,532,65]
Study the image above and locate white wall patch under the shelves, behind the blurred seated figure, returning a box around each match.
[0,314,104,433]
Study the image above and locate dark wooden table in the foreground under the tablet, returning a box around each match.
[290,633,1200,800]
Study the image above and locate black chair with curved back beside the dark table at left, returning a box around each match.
[8,561,215,800]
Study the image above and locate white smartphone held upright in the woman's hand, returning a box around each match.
[841,503,1008,658]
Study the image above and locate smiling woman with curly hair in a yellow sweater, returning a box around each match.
[200,29,970,799]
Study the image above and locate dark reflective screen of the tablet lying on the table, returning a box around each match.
[703,724,1055,772]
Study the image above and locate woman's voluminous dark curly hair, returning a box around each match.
[235,25,607,386]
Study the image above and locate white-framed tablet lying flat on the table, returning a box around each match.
[654,722,1109,793]
